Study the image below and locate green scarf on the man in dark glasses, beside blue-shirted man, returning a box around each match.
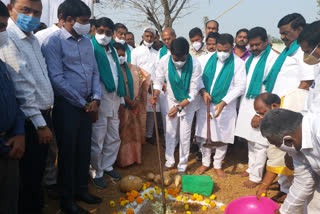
[91,36,127,97]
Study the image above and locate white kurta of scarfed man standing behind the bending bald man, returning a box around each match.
[235,50,279,146]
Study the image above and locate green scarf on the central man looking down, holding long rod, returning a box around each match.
[168,54,193,102]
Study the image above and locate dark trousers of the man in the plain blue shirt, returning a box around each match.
[53,97,92,203]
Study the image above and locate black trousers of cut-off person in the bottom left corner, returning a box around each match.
[0,158,19,214]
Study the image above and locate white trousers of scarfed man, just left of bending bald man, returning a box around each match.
[247,141,268,183]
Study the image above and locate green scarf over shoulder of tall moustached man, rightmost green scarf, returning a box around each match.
[263,40,300,93]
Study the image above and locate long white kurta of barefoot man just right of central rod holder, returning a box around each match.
[196,55,246,144]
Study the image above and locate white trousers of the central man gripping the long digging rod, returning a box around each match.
[165,112,194,172]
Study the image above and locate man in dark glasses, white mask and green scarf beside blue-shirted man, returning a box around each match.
[90,17,127,188]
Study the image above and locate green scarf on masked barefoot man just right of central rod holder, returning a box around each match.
[202,52,234,105]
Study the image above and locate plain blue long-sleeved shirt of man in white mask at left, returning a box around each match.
[41,27,101,108]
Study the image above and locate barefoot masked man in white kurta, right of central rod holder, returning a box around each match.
[194,34,246,177]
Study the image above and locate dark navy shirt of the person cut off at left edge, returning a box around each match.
[0,60,24,136]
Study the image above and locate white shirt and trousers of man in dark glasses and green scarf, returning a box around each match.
[90,49,124,178]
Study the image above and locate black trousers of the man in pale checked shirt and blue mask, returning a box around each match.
[19,113,52,214]
